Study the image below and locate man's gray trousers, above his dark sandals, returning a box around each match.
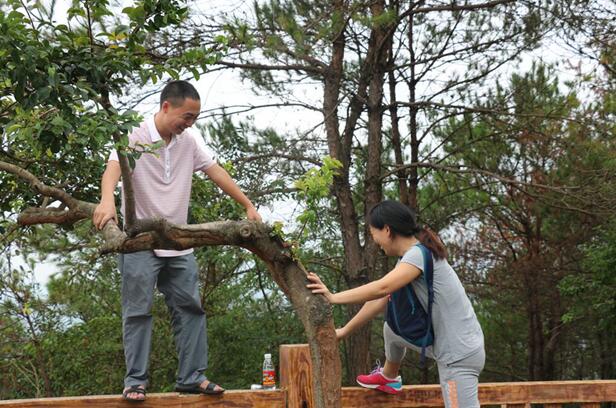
[119,251,207,387]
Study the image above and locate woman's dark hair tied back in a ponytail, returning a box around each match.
[368,200,447,259]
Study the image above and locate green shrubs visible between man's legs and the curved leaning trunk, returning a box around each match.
[208,264,306,389]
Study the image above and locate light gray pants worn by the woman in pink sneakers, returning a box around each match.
[383,323,486,408]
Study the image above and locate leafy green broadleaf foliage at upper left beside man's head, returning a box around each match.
[0,0,224,211]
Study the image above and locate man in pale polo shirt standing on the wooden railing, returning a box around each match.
[93,81,261,401]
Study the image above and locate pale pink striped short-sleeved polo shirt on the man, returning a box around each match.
[109,116,216,257]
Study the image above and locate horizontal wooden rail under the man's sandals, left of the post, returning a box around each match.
[0,390,286,408]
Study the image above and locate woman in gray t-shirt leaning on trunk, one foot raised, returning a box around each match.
[307,201,485,408]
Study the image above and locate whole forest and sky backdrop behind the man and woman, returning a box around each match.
[0,0,616,399]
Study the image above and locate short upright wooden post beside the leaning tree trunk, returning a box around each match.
[280,344,314,408]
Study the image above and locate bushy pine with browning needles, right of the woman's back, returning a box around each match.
[421,65,614,380]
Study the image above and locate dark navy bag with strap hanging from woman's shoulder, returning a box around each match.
[385,244,434,367]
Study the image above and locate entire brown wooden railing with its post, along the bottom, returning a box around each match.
[0,345,616,408]
